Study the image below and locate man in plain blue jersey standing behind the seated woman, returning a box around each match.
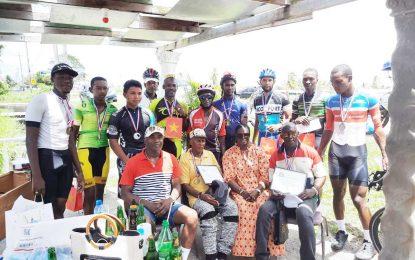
[213,73,248,150]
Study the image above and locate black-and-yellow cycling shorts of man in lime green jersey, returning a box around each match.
[78,147,110,189]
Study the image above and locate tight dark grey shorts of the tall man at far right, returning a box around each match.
[329,142,369,187]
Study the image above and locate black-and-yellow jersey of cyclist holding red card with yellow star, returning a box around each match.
[150,98,188,158]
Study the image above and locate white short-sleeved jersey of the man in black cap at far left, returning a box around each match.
[25,92,73,150]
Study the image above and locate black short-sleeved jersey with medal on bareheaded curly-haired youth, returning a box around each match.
[107,106,154,153]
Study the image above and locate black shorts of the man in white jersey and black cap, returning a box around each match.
[38,148,74,203]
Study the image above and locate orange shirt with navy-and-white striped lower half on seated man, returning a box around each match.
[120,151,181,202]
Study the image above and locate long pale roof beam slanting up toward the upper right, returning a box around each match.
[157,0,356,51]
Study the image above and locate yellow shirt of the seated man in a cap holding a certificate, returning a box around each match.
[180,150,220,207]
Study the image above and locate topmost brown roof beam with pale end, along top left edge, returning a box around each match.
[2,0,169,15]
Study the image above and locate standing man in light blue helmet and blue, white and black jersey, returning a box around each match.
[252,69,291,143]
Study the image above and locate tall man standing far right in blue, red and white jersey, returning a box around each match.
[318,65,388,259]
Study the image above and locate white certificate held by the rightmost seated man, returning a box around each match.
[271,168,307,195]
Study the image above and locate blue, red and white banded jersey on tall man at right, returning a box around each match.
[325,92,382,146]
